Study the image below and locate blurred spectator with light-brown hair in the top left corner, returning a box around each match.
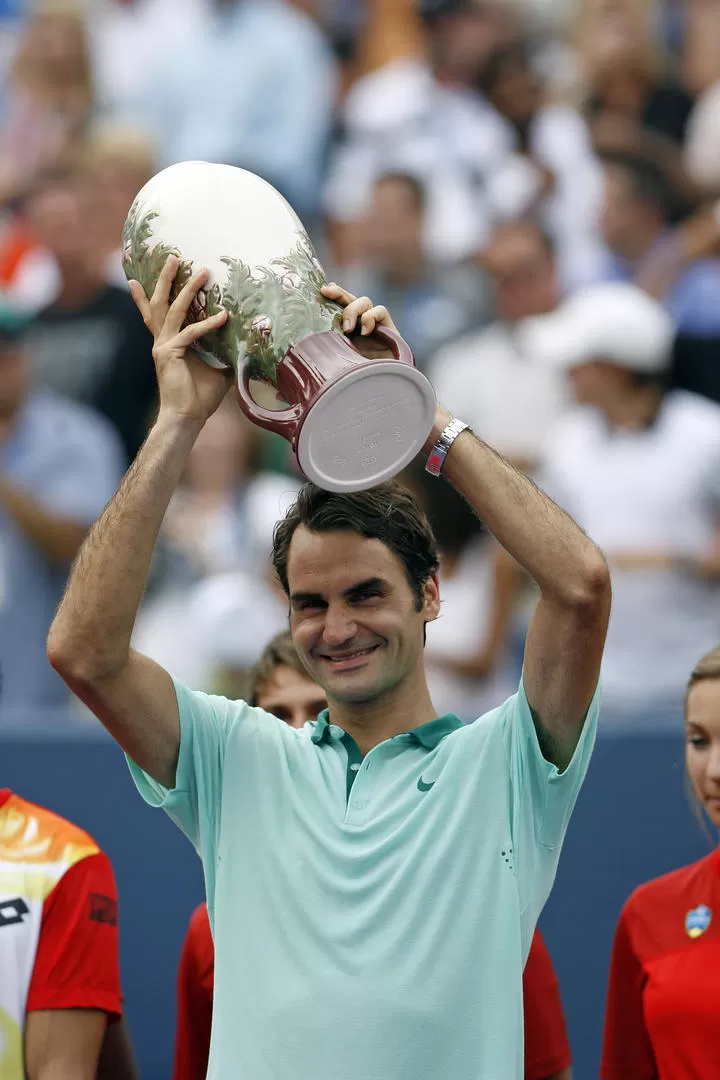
[0,3,93,203]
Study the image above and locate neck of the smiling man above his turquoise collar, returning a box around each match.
[329,675,437,756]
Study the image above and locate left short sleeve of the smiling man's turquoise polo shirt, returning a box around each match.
[127,680,250,861]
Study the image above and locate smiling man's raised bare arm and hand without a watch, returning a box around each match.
[47,256,231,787]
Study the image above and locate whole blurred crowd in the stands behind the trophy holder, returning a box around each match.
[0,0,720,728]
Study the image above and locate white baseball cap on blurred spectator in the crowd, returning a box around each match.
[519,282,675,374]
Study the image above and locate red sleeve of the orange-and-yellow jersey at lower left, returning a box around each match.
[27,852,122,1015]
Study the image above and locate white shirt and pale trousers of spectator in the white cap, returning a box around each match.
[541,391,720,724]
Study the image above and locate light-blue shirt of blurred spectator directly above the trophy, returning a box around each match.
[135,0,335,219]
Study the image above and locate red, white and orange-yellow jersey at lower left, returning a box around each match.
[0,789,122,1080]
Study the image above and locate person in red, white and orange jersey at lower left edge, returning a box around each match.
[0,788,137,1080]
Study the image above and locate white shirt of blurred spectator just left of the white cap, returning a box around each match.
[430,322,570,462]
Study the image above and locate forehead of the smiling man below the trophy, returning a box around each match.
[287,525,409,595]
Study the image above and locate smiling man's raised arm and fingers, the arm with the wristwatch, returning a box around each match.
[324,285,611,769]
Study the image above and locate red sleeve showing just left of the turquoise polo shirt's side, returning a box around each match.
[173,904,215,1080]
